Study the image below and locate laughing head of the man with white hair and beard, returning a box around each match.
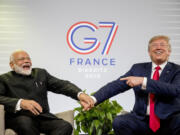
[10,50,32,75]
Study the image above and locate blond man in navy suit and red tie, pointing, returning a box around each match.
[85,35,180,135]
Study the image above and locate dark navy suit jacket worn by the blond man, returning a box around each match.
[94,62,180,119]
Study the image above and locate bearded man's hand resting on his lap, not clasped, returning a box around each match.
[20,99,42,115]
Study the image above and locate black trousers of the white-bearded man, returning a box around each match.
[6,115,73,135]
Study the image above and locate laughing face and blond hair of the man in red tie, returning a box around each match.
[148,36,171,65]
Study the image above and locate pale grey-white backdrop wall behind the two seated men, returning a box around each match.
[0,0,180,112]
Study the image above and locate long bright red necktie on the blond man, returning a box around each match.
[149,66,161,132]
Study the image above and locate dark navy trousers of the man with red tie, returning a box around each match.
[113,113,180,135]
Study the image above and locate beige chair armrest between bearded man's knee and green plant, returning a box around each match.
[55,110,74,128]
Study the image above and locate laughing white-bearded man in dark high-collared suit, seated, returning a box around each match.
[0,50,93,135]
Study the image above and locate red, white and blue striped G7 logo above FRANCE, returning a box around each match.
[66,22,118,55]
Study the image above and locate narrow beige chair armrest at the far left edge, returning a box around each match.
[0,105,5,135]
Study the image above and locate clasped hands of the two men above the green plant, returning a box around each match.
[78,93,96,111]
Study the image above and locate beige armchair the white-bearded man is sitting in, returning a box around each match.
[0,105,74,135]
